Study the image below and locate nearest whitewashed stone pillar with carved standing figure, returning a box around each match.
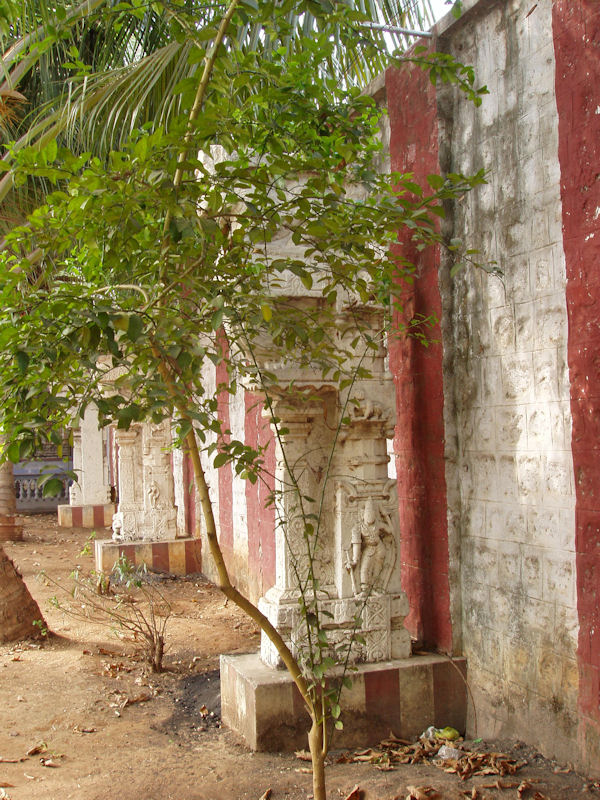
[259,307,411,666]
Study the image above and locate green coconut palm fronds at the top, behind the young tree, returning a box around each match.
[0,0,433,216]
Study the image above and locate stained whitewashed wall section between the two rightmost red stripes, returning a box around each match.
[439,0,578,758]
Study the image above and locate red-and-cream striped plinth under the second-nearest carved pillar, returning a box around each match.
[95,537,202,575]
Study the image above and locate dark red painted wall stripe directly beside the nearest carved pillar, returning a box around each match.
[386,59,452,652]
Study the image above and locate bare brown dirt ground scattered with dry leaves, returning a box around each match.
[0,516,600,800]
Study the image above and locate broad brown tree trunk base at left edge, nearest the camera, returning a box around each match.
[0,547,45,642]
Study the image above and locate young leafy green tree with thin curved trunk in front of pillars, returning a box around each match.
[0,0,481,800]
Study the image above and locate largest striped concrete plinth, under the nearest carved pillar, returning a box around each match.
[221,654,467,752]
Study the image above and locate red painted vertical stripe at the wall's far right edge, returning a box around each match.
[553,0,600,773]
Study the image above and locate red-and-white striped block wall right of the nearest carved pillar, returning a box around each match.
[386,0,600,771]
